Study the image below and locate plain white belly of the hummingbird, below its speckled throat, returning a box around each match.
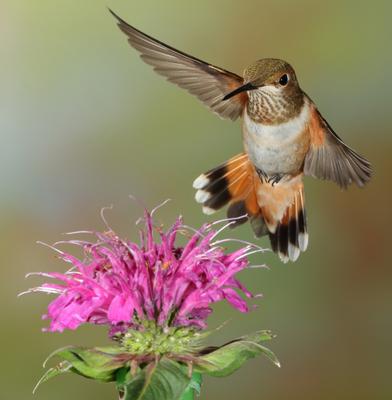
[242,103,309,176]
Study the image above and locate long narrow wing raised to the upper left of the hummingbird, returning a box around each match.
[109,10,247,120]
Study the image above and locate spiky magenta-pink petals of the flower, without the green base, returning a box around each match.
[23,206,262,335]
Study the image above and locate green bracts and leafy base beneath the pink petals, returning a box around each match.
[37,327,280,400]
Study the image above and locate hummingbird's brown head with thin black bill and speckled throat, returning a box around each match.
[223,58,304,123]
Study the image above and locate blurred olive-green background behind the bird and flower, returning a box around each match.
[0,0,392,400]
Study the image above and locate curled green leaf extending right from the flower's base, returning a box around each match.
[194,331,280,376]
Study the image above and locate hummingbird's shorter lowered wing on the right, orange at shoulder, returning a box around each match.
[304,100,372,188]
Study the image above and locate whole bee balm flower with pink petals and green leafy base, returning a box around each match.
[22,206,279,400]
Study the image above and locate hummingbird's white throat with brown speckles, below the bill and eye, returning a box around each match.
[247,87,304,125]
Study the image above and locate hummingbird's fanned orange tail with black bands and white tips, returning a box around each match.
[193,153,308,262]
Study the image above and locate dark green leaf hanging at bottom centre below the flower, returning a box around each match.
[120,358,190,400]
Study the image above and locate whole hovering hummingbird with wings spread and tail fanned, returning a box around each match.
[110,10,372,262]
